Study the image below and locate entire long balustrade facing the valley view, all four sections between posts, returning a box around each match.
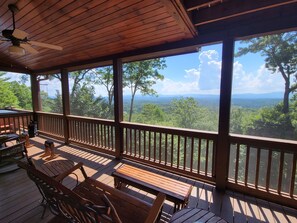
[33,112,297,208]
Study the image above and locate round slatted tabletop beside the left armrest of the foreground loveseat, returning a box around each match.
[37,159,74,177]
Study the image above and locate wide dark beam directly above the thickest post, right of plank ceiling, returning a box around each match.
[198,3,297,39]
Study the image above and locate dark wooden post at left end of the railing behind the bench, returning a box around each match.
[113,58,124,159]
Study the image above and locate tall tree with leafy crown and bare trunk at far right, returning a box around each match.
[236,32,297,114]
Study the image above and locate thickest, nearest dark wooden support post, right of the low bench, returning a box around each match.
[215,38,234,191]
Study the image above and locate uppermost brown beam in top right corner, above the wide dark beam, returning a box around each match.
[193,0,297,26]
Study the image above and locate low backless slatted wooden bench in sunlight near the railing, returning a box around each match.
[112,164,193,211]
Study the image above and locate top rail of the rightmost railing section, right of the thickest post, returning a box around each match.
[230,134,297,152]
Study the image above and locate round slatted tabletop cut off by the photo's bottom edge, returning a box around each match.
[169,208,227,223]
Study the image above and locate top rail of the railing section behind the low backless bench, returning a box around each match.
[121,122,218,140]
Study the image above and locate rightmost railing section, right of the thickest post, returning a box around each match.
[228,132,297,206]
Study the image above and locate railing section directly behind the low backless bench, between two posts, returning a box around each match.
[122,123,217,182]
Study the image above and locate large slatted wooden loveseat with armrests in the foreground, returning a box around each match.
[19,162,165,223]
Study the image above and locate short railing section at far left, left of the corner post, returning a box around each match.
[0,111,33,134]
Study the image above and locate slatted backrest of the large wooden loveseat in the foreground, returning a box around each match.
[18,162,118,223]
